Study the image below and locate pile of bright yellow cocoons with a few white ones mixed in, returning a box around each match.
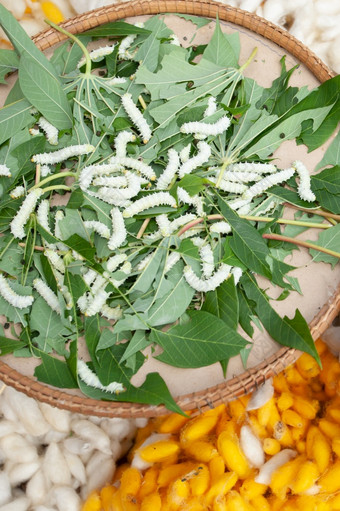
[82,340,340,511]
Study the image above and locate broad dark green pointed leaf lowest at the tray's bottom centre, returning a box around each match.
[150,311,247,368]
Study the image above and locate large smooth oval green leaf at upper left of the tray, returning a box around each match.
[19,52,73,130]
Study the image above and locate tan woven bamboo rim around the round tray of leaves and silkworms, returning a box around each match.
[0,0,340,417]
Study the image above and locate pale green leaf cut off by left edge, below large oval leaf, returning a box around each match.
[0,99,33,144]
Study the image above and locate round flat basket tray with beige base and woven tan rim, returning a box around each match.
[0,0,340,417]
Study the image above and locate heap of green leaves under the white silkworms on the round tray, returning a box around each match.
[0,5,340,411]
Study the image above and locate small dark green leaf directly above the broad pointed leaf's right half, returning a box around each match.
[201,278,239,330]
